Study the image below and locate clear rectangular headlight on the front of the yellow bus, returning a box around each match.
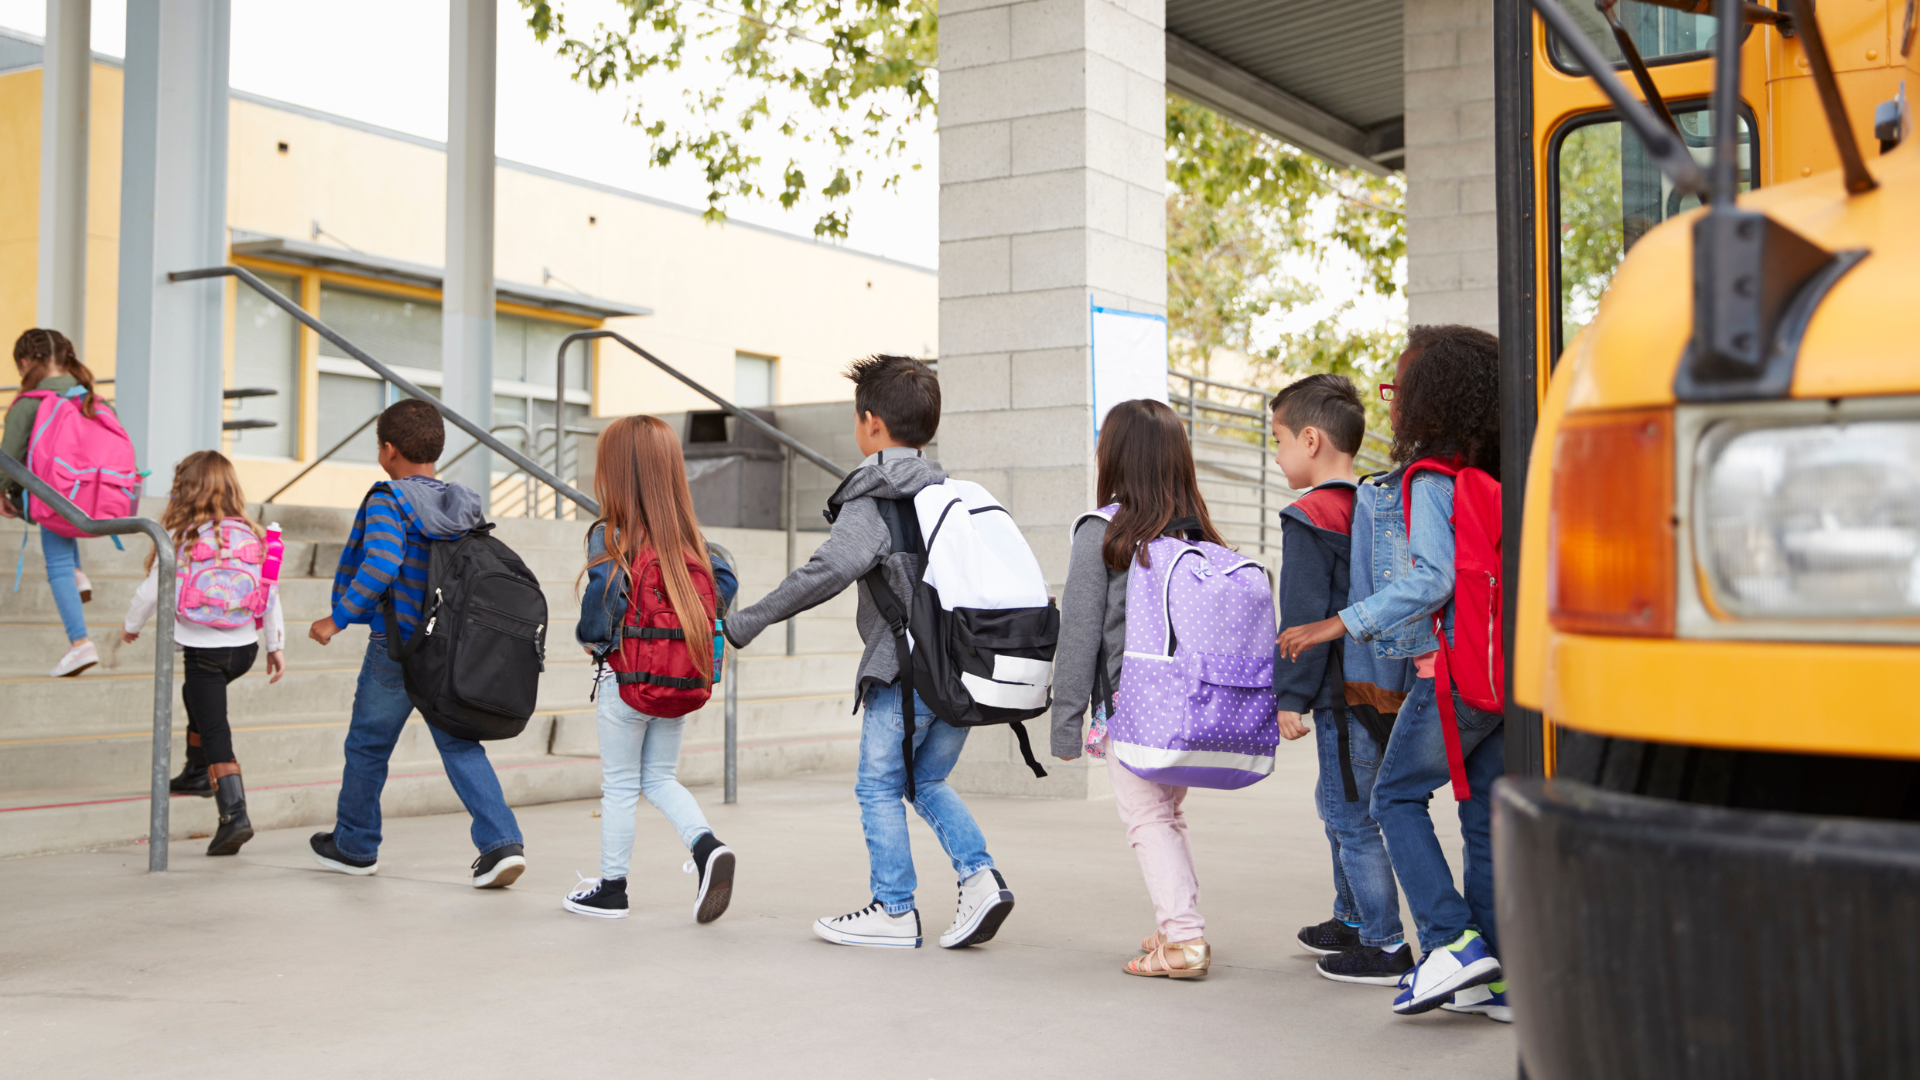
[1693,421,1920,619]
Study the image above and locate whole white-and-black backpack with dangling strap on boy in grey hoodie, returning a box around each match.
[866,480,1060,798]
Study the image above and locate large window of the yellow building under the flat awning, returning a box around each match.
[319,286,593,469]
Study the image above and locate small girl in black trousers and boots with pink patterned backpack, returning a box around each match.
[121,450,286,855]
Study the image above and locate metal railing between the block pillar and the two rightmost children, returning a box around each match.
[1167,371,1392,555]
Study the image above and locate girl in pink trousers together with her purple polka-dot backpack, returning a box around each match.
[1052,400,1251,978]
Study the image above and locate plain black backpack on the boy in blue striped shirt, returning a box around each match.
[380,523,547,740]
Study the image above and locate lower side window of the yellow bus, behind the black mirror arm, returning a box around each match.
[1553,100,1759,357]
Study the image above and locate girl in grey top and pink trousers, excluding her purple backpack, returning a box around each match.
[1052,400,1221,978]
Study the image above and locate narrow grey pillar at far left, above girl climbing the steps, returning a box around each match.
[35,0,94,357]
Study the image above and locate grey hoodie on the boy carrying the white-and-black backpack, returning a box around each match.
[726,446,947,699]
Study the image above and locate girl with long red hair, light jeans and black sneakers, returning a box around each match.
[561,417,737,922]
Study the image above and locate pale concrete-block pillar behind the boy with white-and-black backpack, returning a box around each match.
[939,0,1167,798]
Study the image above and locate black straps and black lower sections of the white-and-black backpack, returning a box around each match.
[866,474,1060,799]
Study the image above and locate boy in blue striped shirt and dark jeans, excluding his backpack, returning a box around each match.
[309,398,526,888]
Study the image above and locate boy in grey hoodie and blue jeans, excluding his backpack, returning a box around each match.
[726,356,1014,949]
